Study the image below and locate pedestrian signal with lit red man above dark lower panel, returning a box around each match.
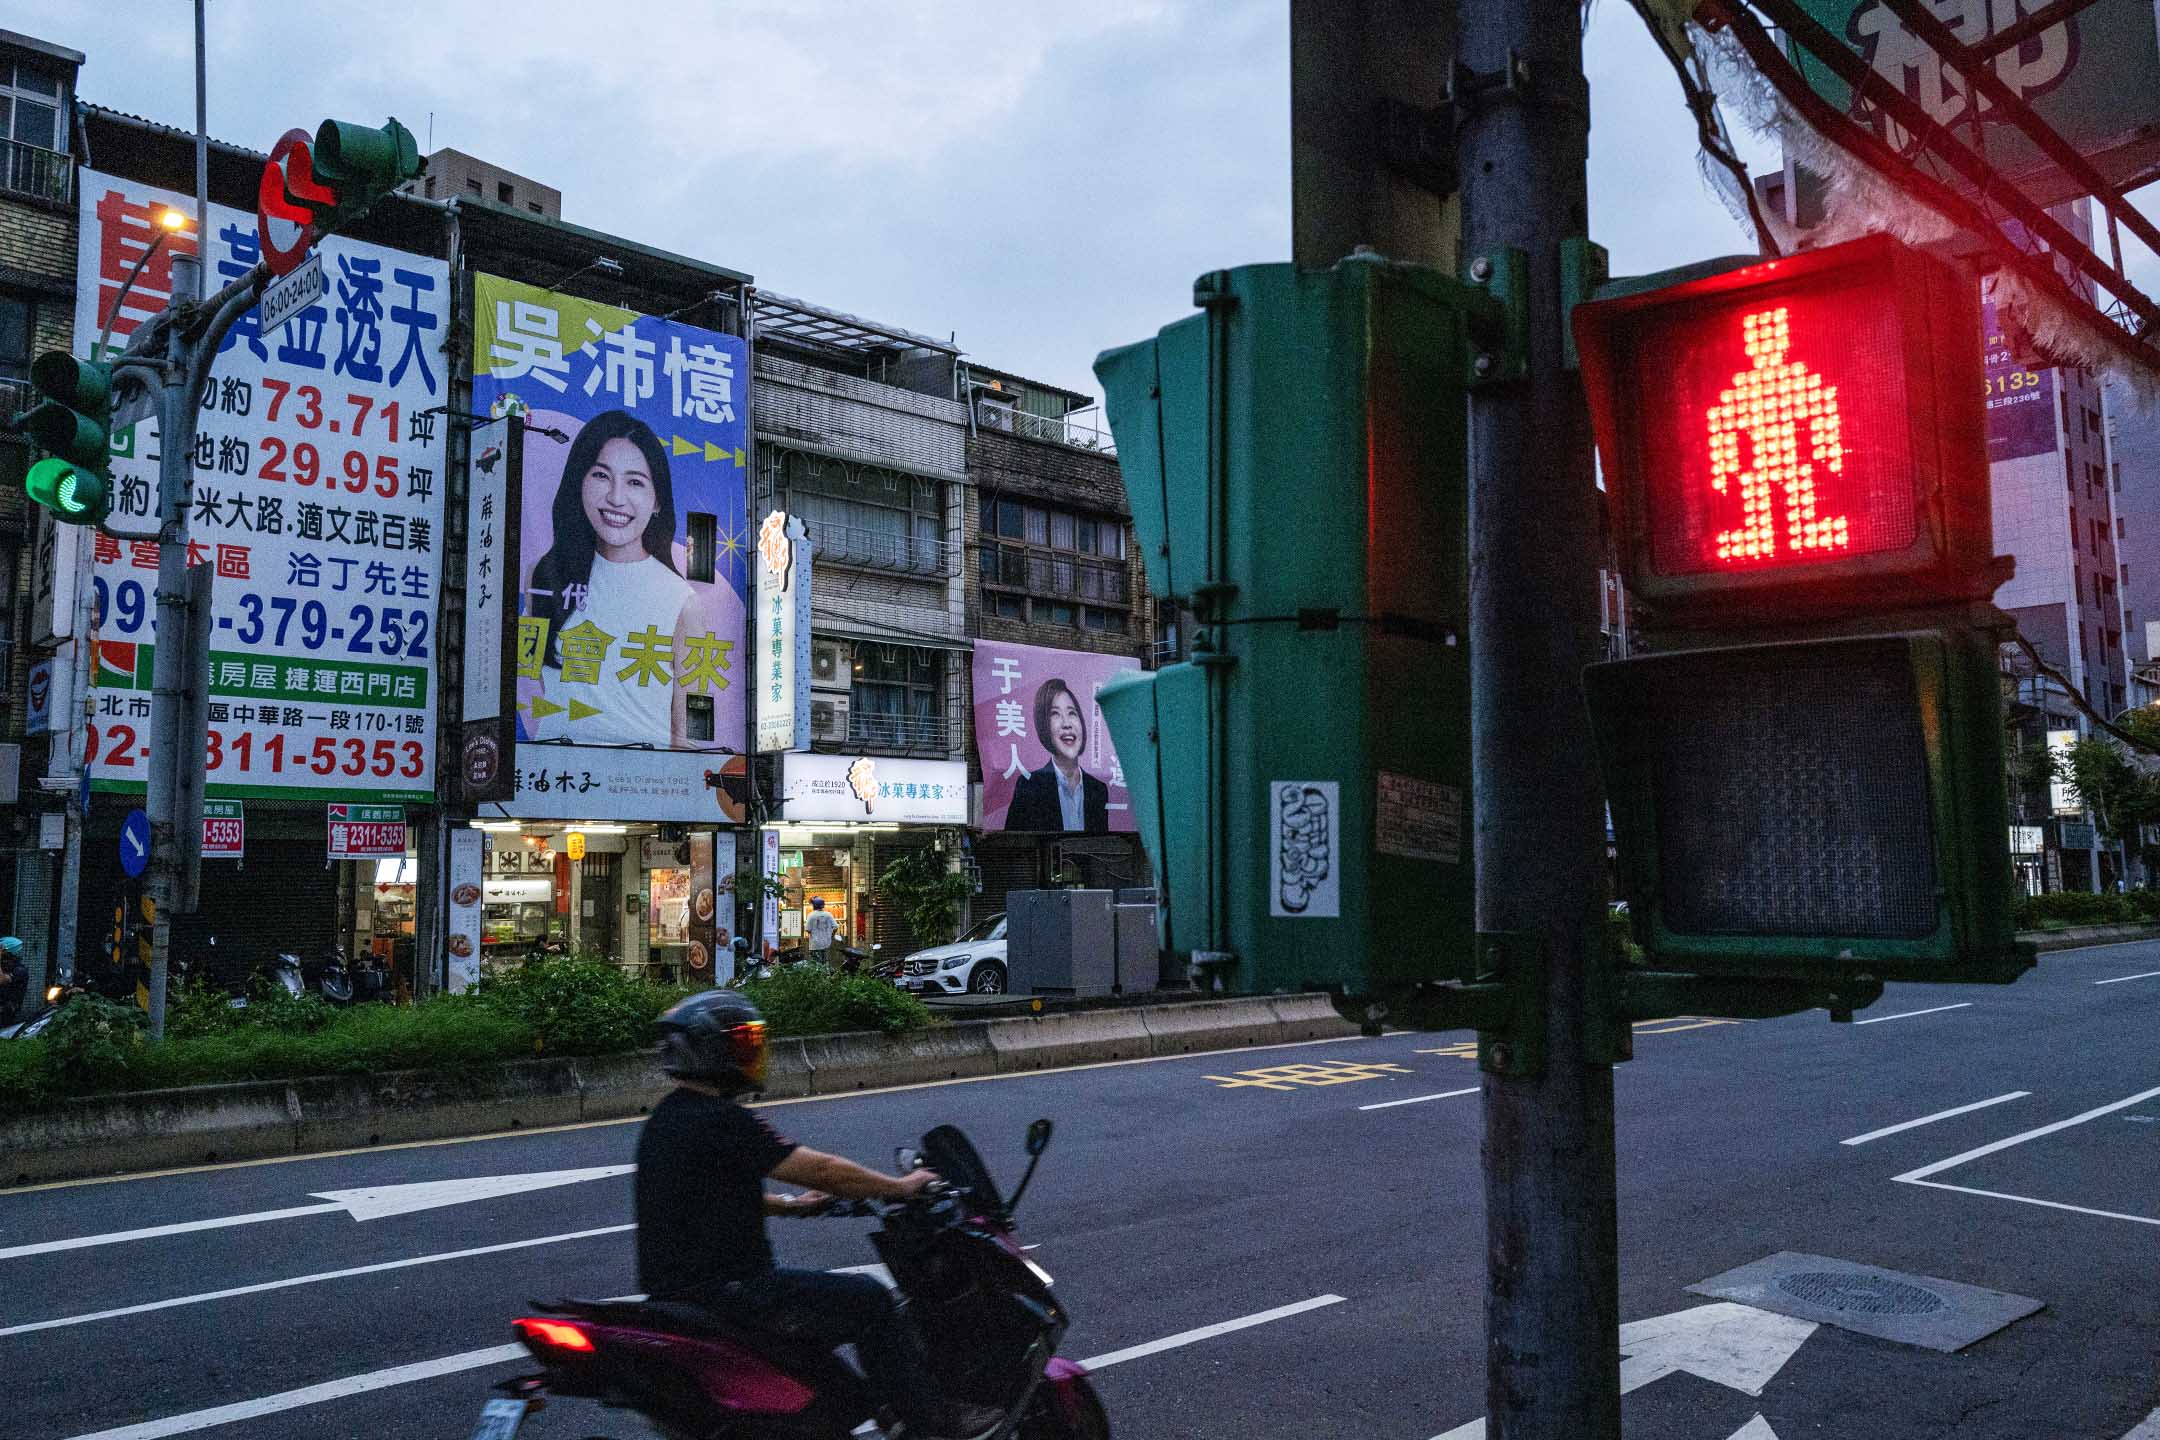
[1575,237,2033,980]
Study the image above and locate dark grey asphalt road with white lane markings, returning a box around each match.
[0,943,2160,1440]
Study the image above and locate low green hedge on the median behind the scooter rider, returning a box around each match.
[0,959,931,1114]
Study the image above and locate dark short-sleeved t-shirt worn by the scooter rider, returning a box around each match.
[637,1090,795,1295]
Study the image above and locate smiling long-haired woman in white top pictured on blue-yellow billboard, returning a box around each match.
[527,410,711,749]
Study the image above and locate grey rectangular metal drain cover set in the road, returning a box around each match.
[1687,1250,2041,1354]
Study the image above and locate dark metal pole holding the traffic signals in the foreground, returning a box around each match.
[1456,0,1620,1440]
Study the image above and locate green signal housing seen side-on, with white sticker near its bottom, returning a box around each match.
[1095,257,1497,995]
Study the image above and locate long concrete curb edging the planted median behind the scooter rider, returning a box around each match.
[0,995,1356,1190]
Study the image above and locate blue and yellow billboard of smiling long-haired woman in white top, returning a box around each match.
[473,274,750,820]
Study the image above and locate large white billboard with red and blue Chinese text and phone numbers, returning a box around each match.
[69,171,449,801]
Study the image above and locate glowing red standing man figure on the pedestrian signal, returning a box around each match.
[1706,304,1851,563]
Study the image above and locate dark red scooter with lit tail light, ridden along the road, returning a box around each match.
[473,1120,1110,1440]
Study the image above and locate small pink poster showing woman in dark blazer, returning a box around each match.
[974,639,1140,836]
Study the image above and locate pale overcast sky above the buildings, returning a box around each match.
[25,0,2151,405]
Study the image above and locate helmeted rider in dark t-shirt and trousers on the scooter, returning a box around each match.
[637,989,1004,1440]
